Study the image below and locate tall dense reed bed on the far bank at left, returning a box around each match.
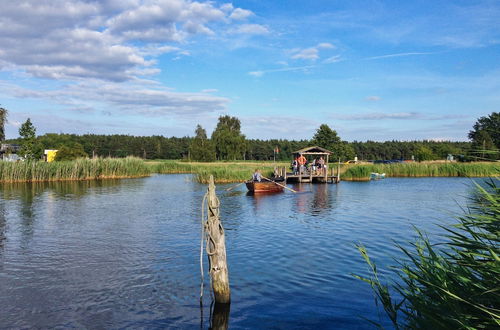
[0,157,151,182]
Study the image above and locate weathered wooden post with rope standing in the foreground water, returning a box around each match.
[206,175,231,304]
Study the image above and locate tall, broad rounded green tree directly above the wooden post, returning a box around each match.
[212,116,246,160]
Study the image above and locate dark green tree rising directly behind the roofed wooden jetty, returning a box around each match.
[312,124,355,161]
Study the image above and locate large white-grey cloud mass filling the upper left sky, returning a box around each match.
[0,0,258,82]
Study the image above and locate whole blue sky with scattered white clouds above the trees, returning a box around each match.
[0,0,500,141]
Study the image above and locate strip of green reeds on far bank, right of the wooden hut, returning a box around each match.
[342,163,500,181]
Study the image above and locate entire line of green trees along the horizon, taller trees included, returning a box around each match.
[0,112,500,162]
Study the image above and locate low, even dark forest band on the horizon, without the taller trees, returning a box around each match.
[6,133,472,161]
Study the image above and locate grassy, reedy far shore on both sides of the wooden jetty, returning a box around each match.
[0,157,500,183]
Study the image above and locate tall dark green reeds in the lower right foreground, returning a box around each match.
[356,179,500,329]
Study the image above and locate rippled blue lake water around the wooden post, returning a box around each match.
[0,175,480,329]
